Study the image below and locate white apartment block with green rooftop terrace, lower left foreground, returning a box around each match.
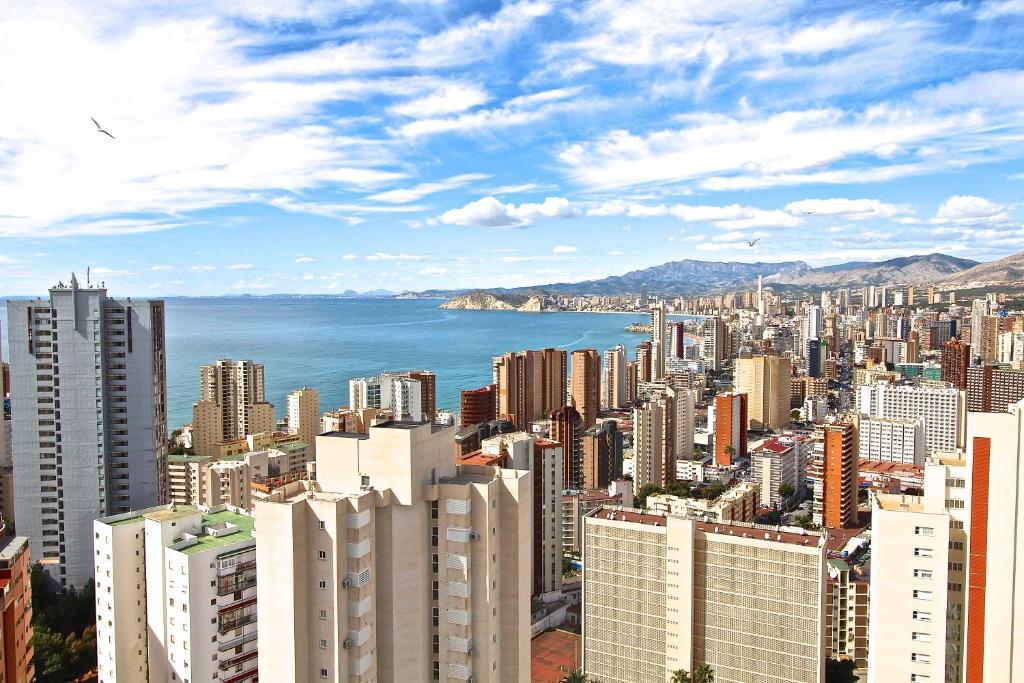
[93,505,258,683]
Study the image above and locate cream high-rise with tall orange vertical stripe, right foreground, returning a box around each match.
[868,402,1024,682]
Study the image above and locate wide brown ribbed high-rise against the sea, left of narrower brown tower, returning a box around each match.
[494,348,567,431]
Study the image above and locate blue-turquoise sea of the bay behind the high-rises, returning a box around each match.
[0,297,700,429]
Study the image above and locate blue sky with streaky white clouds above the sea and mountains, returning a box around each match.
[0,0,1024,296]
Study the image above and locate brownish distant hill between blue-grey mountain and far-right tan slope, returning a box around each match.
[765,254,978,288]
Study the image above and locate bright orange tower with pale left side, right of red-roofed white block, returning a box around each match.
[810,423,858,528]
